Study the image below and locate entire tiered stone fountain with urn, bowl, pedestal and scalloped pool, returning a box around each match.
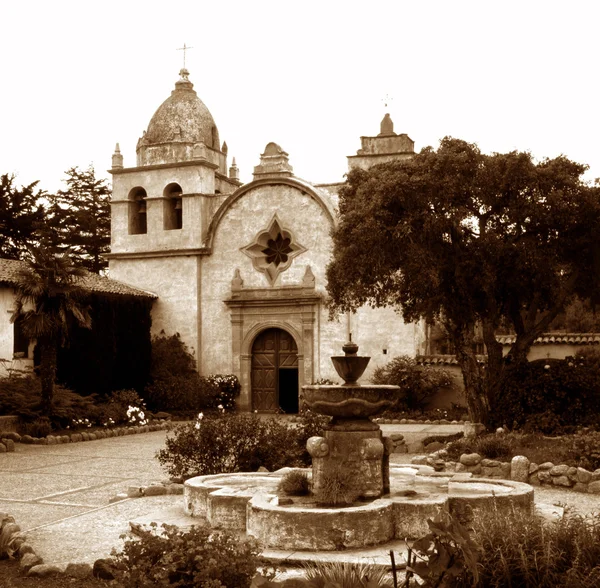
[184,341,533,551]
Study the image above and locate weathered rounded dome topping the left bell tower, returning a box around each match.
[137,69,220,164]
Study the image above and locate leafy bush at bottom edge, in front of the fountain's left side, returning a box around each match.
[113,523,260,588]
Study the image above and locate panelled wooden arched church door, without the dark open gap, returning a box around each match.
[252,329,298,412]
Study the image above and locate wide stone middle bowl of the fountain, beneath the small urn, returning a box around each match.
[302,384,402,419]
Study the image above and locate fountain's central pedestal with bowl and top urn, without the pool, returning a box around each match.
[302,342,400,502]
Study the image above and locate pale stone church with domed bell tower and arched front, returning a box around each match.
[110,69,423,412]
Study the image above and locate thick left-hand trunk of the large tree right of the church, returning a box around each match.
[448,324,490,427]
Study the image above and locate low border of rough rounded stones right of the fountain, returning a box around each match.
[411,449,600,494]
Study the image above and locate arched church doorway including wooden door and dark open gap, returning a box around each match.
[252,329,298,413]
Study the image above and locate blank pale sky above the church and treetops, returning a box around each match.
[0,0,600,191]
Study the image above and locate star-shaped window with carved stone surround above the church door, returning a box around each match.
[241,215,306,286]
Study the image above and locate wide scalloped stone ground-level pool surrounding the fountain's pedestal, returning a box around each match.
[184,466,533,551]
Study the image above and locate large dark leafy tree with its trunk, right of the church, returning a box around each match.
[327,137,600,422]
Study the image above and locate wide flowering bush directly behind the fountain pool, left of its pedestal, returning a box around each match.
[157,413,306,478]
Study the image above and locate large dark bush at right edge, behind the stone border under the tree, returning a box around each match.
[490,351,600,434]
